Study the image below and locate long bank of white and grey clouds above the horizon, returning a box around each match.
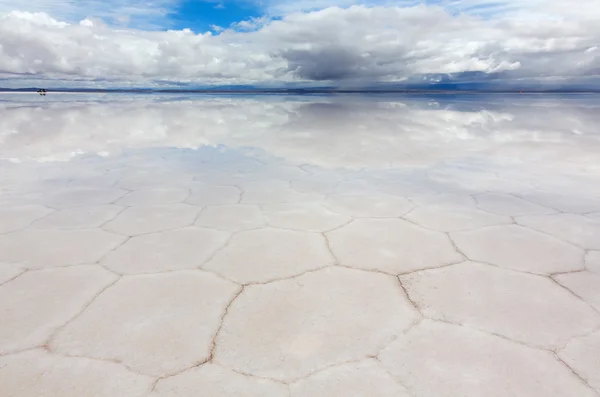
[0,0,600,85]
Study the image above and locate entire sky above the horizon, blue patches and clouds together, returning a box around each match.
[0,0,600,89]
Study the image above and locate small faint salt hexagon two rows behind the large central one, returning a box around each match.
[324,194,414,218]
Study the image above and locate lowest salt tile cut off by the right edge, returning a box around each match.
[558,332,600,393]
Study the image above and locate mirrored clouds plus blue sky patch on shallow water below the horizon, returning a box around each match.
[0,94,600,206]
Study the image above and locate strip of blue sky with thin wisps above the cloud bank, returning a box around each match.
[0,0,510,32]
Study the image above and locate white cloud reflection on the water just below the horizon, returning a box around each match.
[0,94,600,169]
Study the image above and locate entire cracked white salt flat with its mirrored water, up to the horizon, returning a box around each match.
[0,94,600,397]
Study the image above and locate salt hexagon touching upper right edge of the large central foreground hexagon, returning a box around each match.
[327,219,464,274]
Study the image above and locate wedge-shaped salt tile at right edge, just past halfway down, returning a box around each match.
[517,214,600,249]
